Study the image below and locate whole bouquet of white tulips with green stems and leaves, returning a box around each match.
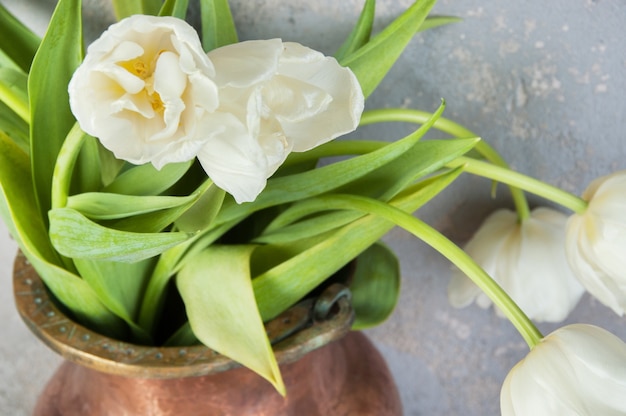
[0,0,626,415]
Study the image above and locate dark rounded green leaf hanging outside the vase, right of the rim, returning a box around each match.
[350,243,400,330]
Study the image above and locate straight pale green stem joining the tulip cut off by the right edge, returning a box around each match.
[446,156,587,214]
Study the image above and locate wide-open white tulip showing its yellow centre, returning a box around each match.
[69,15,218,169]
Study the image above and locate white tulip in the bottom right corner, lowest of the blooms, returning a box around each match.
[500,324,626,416]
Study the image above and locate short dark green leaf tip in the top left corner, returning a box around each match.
[0,3,40,73]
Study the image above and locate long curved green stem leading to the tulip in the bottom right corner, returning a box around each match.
[319,194,543,349]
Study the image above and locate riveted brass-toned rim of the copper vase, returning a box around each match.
[13,252,354,379]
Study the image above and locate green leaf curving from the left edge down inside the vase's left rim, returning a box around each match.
[0,132,121,336]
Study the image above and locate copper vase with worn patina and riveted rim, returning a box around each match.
[13,254,402,416]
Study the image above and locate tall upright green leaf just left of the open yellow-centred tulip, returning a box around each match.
[28,0,83,221]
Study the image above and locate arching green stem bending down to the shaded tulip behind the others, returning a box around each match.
[361,108,530,222]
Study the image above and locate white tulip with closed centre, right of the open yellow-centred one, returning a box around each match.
[198,39,364,203]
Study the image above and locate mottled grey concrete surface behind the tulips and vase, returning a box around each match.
[0,0,626,416]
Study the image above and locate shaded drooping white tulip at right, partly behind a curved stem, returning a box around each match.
[448,208,584,322]
